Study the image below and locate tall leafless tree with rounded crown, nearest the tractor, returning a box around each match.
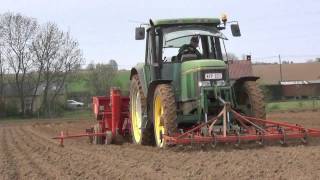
[32,23,83,116]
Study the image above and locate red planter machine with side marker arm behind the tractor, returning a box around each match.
[53,88,130,146]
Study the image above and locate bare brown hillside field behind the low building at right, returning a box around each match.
[252,63,320,85]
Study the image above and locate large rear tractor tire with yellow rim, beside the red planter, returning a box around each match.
[130,75,153,145]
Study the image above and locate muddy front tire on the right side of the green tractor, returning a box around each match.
[238,81,266,119]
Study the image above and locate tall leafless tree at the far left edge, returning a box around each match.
[0,13,38,116]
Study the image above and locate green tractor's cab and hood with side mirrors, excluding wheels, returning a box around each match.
[136,17,240,104]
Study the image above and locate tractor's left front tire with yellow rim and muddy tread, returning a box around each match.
[152,84,177,148]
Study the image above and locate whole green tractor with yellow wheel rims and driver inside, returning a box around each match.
[130,17,266,147]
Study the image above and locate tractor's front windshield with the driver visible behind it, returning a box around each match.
[162,25,226,62]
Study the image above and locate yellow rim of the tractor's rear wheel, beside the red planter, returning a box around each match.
[131,91,142,143]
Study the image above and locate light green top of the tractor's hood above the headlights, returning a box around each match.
[181,59,226,74]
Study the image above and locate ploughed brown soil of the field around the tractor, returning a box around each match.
[0,111,320,180]
